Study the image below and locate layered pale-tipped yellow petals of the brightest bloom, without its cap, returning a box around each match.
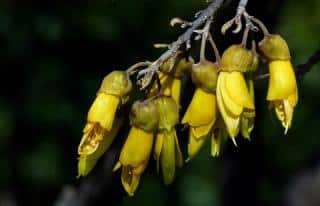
[217,71,255,140]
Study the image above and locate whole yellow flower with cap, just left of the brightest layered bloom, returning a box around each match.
[181,61,217,161]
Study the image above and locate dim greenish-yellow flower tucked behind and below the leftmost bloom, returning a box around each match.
[78,118,122,177]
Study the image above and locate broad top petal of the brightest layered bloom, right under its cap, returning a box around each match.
[225,71,254,109]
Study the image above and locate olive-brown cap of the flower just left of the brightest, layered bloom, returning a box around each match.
[191,61,218,93]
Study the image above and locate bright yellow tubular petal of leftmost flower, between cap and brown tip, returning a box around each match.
[88,93,120,131]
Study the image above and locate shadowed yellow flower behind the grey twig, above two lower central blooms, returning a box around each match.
[149,55,191,105]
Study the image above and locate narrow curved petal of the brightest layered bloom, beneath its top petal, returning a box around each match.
[218,72,243,116]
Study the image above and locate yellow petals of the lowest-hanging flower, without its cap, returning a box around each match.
[113,126,153,196]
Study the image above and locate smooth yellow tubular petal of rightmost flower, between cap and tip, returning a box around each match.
[267,60,297,101]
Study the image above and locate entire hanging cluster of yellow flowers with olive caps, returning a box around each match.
[78,18,298,196]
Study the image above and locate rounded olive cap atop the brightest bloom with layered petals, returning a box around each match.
[221,45,253,72]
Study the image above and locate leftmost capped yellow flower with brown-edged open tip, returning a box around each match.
[78,71,132,155]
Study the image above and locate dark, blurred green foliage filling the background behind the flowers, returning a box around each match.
[0,0,320,206]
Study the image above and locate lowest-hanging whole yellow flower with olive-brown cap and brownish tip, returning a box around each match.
[113,100,159,196]
